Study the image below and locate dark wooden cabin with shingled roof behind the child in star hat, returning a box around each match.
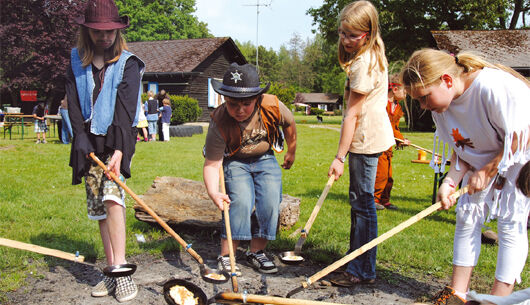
[128,37,247,121]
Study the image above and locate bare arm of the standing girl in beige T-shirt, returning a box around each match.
[328,90,366,180]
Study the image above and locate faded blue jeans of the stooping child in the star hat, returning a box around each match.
[221,151,282,240]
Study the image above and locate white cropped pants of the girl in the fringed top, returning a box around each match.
[453,203,528,284]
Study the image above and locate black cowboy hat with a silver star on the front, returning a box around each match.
[212,63,271,98]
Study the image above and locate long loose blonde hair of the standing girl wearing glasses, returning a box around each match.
[338,1,387,71]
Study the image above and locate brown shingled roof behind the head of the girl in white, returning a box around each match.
[431,29,530,68]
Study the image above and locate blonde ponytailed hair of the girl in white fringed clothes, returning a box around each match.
[400,49,530,92]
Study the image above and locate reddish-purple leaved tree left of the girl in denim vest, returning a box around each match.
[0,0,84,105]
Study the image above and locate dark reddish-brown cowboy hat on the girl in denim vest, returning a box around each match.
[74,0,129,30]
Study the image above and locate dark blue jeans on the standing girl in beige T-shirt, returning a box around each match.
[346,153,380,280]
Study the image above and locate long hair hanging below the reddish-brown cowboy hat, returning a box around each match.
[77,26,129,67]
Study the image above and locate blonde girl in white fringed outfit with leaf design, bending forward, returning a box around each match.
[402,49,530,304]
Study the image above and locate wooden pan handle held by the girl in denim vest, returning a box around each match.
[90,153,204,265]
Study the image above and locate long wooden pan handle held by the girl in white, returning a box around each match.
[302,185,468,288]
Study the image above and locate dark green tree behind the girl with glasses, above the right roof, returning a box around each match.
[308,0,530,61]
